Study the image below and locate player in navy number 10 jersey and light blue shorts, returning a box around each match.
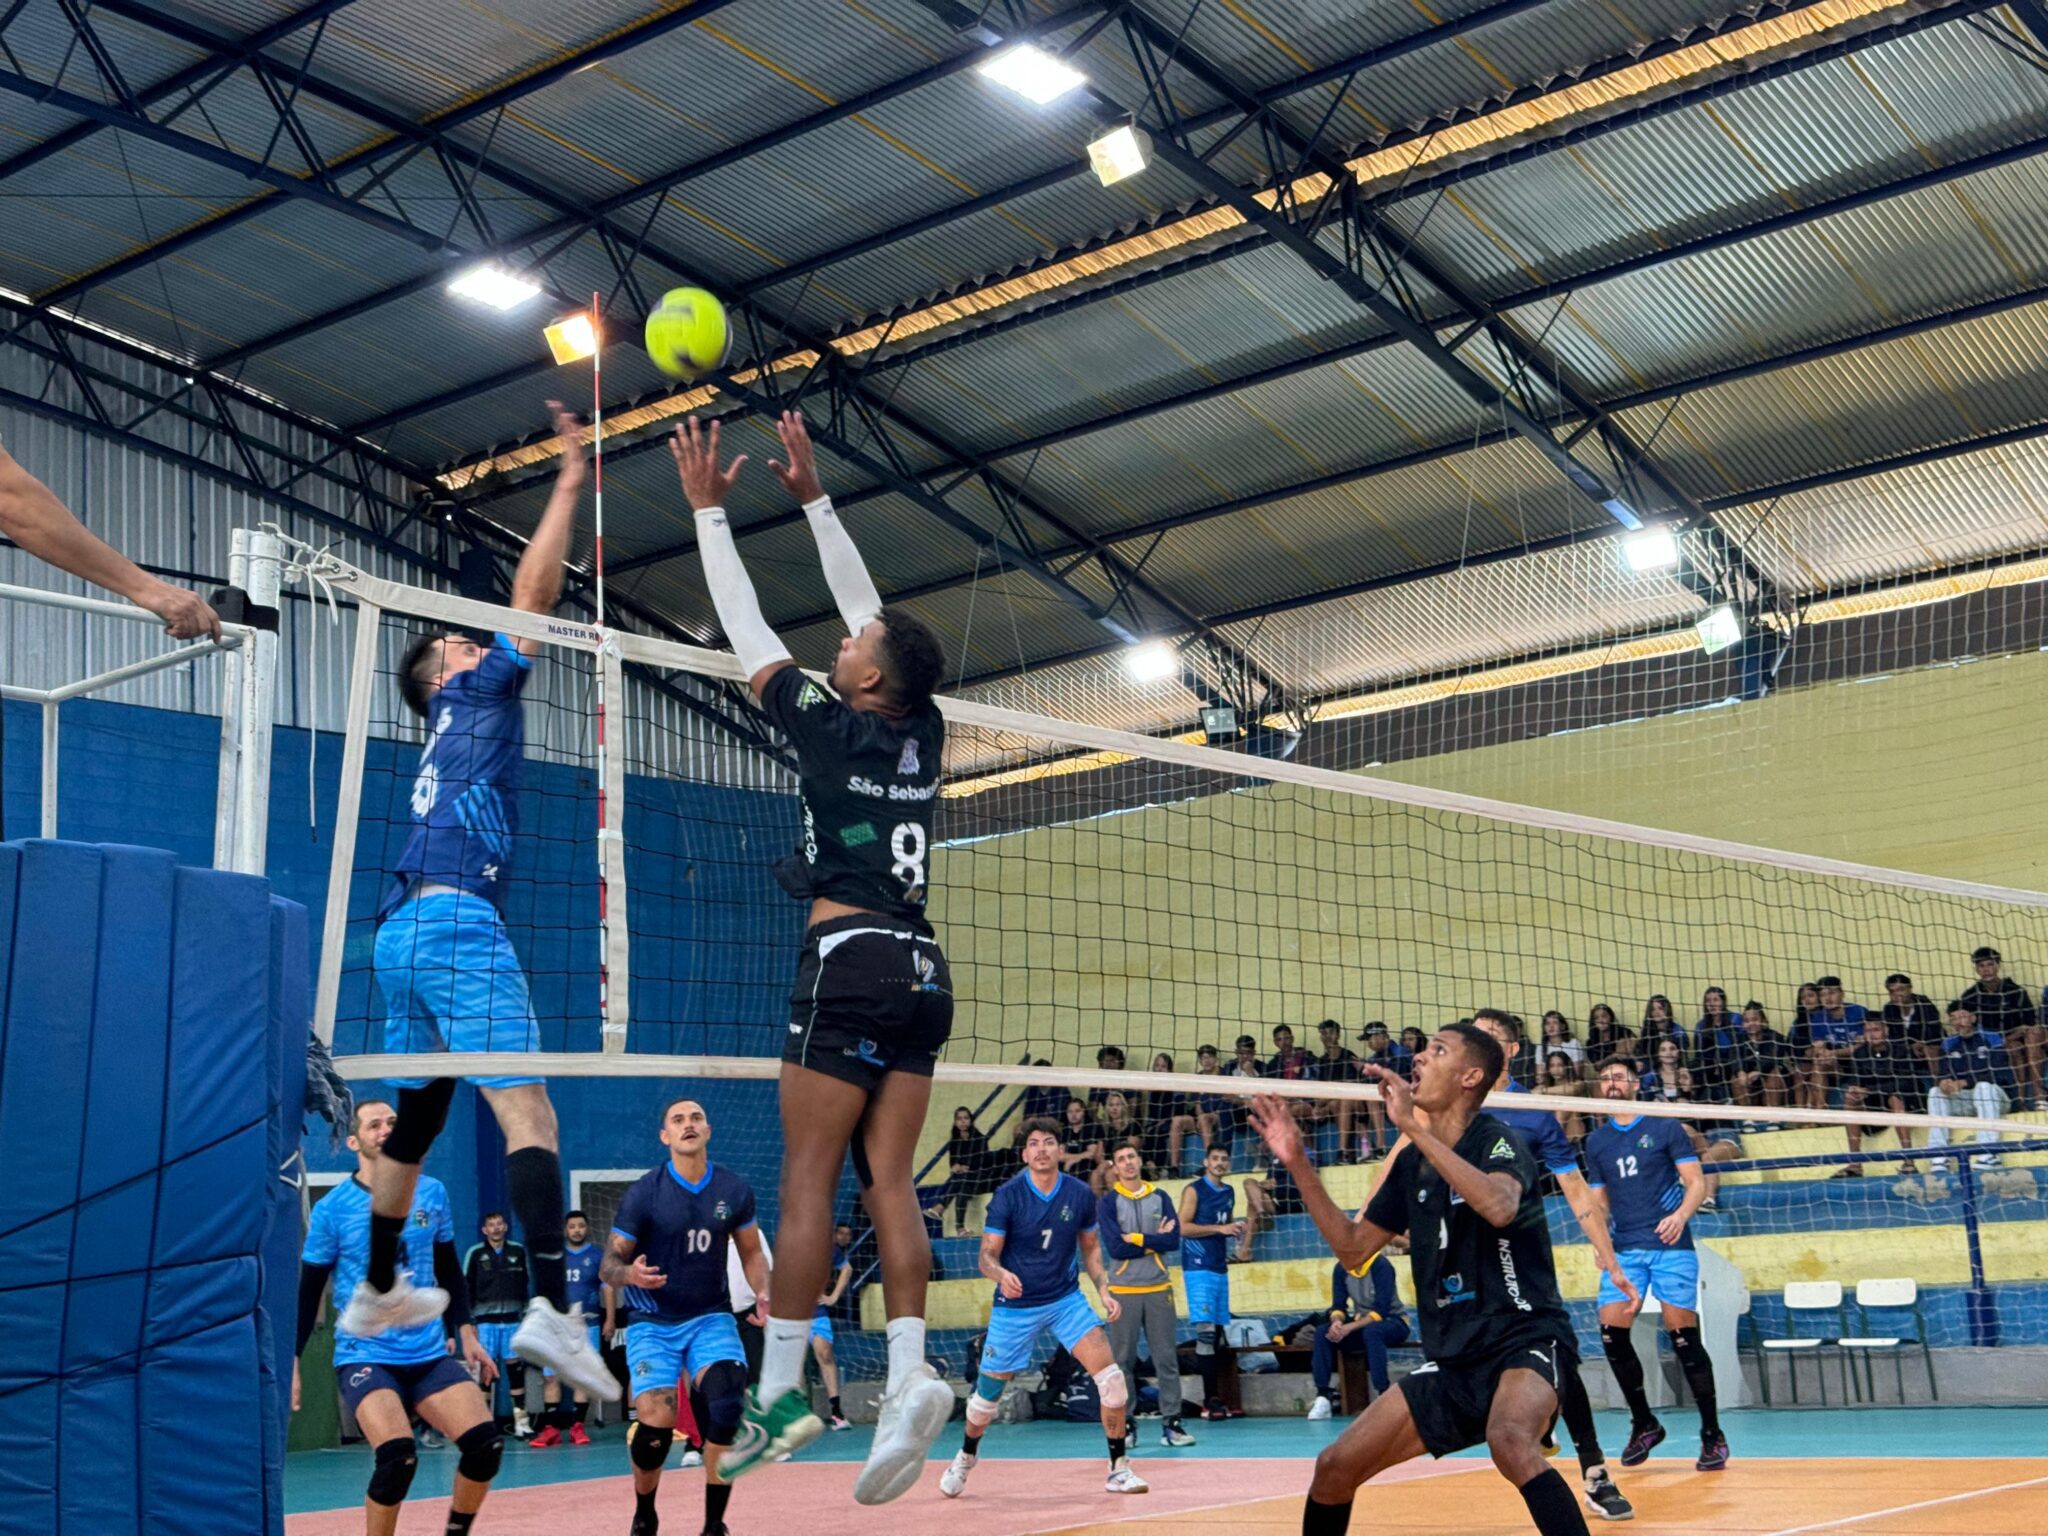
[602,1098,768,1536]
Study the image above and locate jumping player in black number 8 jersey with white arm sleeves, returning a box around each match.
[672,412,954,1503]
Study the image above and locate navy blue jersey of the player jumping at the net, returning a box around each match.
[377,635,532,918]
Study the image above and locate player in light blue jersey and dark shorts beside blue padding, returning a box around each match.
[291,1098,504,1536]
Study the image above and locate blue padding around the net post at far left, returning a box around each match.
[0,842,309,1536]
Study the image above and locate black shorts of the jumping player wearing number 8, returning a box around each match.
[782,913,952,1090]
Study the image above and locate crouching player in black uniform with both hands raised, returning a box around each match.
[1251,1024,1585,1536]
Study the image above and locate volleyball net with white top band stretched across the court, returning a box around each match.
[317,548,2048,1392]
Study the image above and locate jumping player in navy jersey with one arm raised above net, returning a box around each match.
[348,401,618,1403]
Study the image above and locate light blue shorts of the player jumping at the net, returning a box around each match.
[377,891,543,1087]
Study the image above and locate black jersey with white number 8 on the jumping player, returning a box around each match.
[762,668,946,922]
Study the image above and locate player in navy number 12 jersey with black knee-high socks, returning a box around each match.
[1585,1057,1729,1473]
